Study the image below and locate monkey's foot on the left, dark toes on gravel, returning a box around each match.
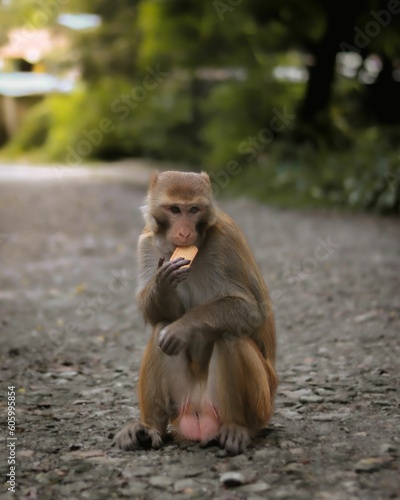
[115,422,163,451]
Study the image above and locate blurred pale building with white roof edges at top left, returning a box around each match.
[0,14,101,145]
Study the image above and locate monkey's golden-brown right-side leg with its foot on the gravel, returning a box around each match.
[208,337,277,454]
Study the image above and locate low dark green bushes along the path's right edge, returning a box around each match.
[225,127,400,213]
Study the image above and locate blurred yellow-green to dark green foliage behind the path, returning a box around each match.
[1,0,400,212]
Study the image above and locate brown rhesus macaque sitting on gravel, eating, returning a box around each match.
[116,171,277,454]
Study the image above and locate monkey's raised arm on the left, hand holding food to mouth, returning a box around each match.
[137,233,188,325]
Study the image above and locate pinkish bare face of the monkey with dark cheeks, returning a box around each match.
[154,204,208,251]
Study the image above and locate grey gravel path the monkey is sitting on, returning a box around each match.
[0,162,400,500]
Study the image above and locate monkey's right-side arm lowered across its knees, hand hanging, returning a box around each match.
[159,220,268,355]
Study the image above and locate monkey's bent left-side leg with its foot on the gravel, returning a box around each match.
[115,323,169,450]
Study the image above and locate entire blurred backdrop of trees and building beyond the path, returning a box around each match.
[0,0,400,213]
